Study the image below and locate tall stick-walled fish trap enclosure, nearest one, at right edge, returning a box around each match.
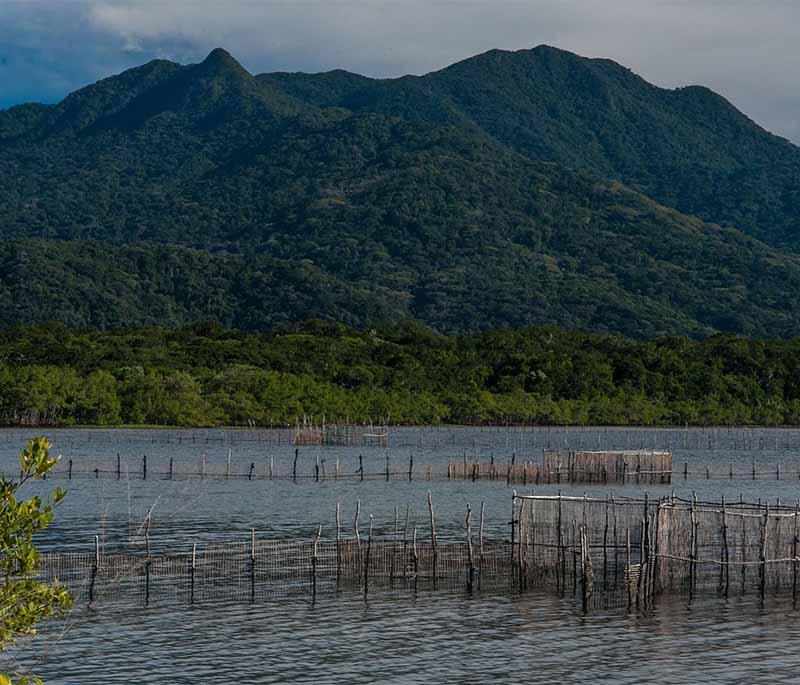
[512,495,800,610]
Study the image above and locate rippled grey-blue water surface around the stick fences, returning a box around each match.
[0,429,800,684]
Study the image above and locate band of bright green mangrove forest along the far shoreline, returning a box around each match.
[0,321,800,426]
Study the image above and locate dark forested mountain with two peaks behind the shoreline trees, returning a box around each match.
[0,47,800,337]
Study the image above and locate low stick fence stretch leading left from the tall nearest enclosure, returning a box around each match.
[40,496,512,604]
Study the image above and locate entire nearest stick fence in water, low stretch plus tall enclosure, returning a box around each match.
[36,494,800,611]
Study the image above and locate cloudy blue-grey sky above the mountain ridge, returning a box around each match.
[0,0,800,143]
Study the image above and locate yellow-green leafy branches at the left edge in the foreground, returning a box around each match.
[0,438,71,685]
